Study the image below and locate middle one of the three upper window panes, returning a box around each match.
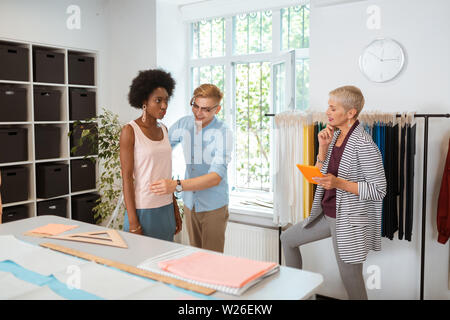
[233,11,272,54]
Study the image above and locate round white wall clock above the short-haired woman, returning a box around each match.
[359,39,405,82]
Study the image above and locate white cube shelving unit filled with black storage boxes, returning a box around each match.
[0,38,98,224]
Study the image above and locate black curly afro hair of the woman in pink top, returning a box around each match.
[128,69,175,109]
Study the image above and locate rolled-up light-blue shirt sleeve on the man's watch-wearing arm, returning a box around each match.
[208,127,233,179]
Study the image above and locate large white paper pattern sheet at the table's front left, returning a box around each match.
[0,235,197,300]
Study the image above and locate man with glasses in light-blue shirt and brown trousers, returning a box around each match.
[150,84,233,252]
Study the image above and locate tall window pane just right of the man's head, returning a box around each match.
[235,62,271,191]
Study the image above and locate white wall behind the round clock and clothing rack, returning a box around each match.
[303,0,450,299]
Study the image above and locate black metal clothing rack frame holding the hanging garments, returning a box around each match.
[265,113,450,300]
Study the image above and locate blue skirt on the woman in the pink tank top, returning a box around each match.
[123,203,176,241]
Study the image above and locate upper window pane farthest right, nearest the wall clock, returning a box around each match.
[281,5,309,50]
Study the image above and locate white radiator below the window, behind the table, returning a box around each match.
[175,222,278,263]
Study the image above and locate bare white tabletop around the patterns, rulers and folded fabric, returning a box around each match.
[0,216,323,300]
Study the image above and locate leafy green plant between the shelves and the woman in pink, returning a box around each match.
[69,108,125,229]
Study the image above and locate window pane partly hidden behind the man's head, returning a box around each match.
[192,66,225,120]
